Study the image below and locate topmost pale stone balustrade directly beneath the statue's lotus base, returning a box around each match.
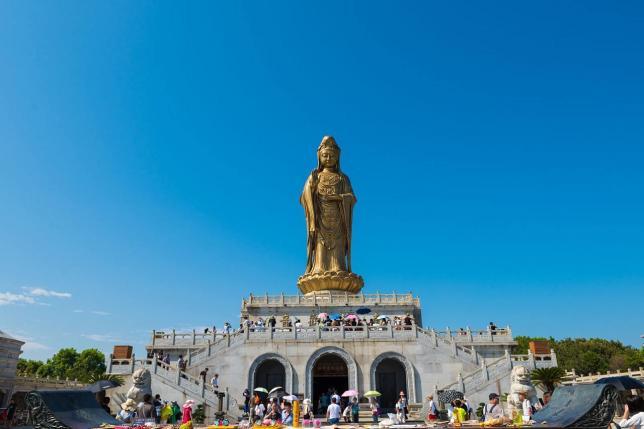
[243,292,420,306]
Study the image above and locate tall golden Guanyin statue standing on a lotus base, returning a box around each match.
[297,136,364,294]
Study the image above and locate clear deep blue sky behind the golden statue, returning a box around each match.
[0,1,644,358]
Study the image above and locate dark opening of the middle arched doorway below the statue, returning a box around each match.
[312,353,349,414]
